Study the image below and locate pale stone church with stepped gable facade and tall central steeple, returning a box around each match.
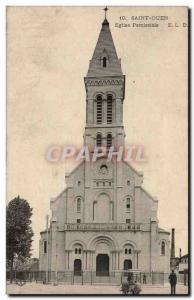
[39,11,170,280]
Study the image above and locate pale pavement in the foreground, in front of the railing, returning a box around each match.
[6,282,188,295]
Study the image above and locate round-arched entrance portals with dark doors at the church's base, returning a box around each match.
[67,236,139,276]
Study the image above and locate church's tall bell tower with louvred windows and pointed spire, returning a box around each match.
[84,8,125,152]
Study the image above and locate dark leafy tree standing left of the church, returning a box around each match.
[6,196,33,282]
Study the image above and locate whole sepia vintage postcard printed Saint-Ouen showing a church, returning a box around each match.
[6,6,190,296]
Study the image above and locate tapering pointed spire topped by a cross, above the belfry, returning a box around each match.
[87,7,123,77]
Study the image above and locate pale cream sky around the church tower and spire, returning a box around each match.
[7,6,188,257]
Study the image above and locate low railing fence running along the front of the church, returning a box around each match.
[6,271,188,285]
